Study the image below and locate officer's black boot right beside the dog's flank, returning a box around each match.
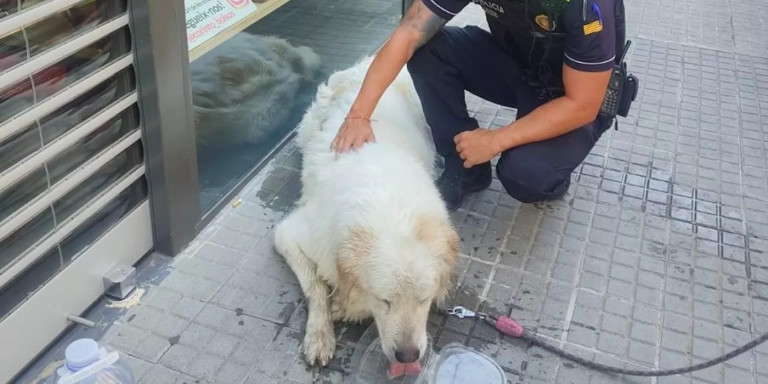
[437,158,493,212]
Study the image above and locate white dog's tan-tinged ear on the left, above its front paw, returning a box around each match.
[336,228,373,308]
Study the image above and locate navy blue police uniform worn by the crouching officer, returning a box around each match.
[408,0,624,202]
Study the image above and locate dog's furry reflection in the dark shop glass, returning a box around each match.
[190,33,320,152]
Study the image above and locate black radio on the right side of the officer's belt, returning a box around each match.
[600,41,639,129]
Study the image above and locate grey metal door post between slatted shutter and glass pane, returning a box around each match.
[128,0,201,256]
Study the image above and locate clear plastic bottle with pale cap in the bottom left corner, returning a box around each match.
[49,339,135,384]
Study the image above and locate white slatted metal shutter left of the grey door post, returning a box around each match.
[0,0,149,382]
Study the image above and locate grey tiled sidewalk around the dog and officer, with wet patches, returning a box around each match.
[16,0,768,384]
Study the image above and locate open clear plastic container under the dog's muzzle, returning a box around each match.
[352,325,506,384]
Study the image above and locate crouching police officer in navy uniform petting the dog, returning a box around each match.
[332,0,625,210]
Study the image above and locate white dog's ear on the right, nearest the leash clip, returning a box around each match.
[416,217,459,305]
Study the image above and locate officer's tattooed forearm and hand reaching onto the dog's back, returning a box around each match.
[350,0,446,117]
